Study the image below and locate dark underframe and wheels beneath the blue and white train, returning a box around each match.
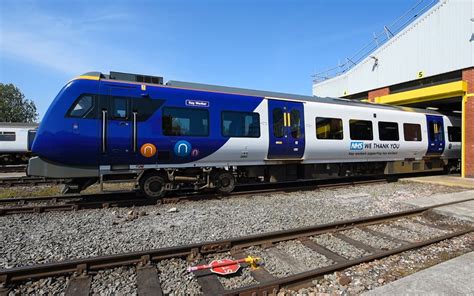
[63,157,460,198]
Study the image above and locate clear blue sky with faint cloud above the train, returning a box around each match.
[0,0,436,118]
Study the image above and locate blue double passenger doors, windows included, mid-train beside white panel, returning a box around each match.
[268,100,305,159]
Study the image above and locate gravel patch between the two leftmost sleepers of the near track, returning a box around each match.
[91,267,138,295]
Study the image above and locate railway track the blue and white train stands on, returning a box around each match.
[0,179,386,216]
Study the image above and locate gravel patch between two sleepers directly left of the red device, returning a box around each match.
[156,259,201,296]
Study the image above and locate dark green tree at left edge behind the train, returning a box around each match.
[0,83,38,123]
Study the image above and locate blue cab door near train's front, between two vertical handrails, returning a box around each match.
[101,87,138,168]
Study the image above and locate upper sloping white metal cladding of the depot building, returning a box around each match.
[313,0,474,97]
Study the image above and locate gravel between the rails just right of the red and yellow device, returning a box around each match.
[245,241,334,277]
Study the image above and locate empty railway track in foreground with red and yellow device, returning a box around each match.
[0,199,474,295]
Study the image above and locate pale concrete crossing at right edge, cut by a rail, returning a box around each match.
[406,190,474,222]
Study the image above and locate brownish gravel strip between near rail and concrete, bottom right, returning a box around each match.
[278,233,474,296]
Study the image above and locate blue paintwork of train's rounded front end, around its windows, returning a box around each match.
[32,79,265,167]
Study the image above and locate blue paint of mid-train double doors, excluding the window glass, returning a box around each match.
[268,100,305,159]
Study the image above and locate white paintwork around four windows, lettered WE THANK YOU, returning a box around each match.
[304,103,428,163]
